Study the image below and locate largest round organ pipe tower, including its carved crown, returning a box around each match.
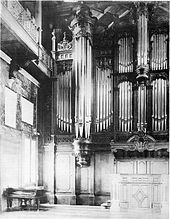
[70,5,95,139]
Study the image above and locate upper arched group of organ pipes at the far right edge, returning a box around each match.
[150,33,168,70]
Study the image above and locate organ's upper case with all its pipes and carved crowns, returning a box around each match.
[56,3,169,164]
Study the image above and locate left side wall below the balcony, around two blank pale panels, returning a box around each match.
[0,54,38,210]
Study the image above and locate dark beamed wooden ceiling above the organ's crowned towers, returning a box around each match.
[43,0,169,33]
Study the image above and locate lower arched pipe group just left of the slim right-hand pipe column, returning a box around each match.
[119,81,133,132]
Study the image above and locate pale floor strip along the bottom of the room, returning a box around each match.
[0,205,168,219]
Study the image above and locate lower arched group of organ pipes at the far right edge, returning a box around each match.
[152,78,167,131]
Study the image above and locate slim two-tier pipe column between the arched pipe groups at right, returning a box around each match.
[136,2,149,131]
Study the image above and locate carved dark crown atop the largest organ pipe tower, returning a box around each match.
[70,3,96,39]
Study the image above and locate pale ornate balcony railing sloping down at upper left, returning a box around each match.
[1,0,52,70]
